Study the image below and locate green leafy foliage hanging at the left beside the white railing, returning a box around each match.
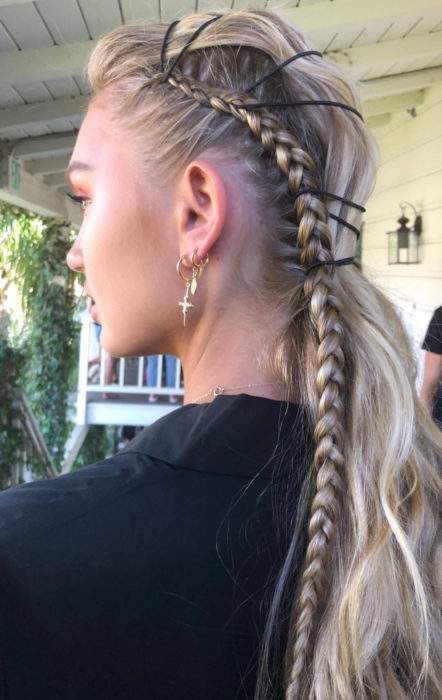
[0,205,79,475]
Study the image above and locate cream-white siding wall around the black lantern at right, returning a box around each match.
[362,86,442,378]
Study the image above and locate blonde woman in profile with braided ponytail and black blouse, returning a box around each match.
[0,11,440,700]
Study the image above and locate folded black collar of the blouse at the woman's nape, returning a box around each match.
[120,394,306,479]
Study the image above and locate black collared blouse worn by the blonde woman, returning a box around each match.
[0,394,303,700]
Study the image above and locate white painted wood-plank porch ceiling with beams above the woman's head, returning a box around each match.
[0,0,442,219]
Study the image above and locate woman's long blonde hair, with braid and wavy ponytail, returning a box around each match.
[89,11,441,700]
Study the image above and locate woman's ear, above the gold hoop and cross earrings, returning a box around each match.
[178,161,226,264]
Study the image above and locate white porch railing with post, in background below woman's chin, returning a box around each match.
[76,313,184,425]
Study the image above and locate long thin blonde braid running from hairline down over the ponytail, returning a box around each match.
[169,69,345,700]
